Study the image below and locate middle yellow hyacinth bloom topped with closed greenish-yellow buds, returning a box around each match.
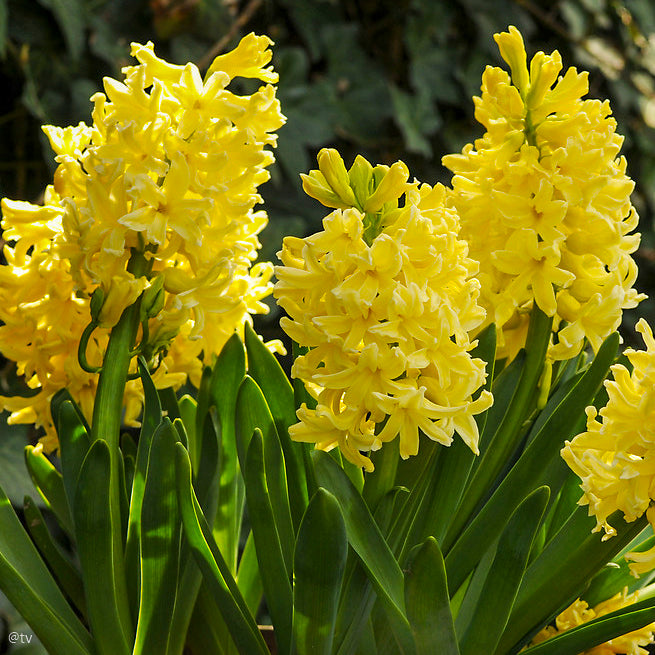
[274,150,492,470]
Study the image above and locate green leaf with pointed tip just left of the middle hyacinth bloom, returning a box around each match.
[245,323,308,530]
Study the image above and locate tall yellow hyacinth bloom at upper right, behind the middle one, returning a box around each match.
[443,27,644,359]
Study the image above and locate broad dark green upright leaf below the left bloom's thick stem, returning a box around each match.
[74,439,133,655]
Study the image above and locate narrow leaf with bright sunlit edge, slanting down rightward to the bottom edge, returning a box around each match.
[175,444,268,655]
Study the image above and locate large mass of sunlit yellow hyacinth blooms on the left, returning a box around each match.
[0,34,284,447]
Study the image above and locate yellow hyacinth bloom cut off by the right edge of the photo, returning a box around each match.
[562,319,655,574]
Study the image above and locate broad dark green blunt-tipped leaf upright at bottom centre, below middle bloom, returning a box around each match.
[293,489,348,655]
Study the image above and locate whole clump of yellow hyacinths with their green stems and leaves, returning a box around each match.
[0,23,655,655]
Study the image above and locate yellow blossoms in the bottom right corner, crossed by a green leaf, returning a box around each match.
[530,589,655,655]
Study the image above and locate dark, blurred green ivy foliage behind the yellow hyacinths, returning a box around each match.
[0,0,655,334]
